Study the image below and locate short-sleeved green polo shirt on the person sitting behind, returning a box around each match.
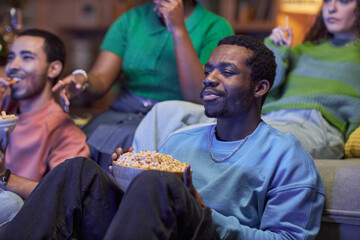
[101,3,233,101]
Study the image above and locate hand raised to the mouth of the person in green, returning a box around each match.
[154,0,186,33]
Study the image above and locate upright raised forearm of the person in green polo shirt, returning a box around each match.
[172,26,205,103]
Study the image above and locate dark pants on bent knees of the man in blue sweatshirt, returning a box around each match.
[0,157,218,240]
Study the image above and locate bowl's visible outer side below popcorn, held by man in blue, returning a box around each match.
[113,161,184,192]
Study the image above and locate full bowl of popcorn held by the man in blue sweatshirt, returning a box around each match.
[113,151,188,192]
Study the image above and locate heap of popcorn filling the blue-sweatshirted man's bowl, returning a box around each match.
[114,151,188,172]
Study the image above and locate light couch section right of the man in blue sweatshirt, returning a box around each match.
[315,158,360,240]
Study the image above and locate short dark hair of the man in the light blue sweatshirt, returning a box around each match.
[218,35,276,104]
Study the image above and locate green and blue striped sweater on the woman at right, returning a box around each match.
[262,38,360,138]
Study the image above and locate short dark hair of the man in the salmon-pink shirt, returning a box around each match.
[18,28,66,75]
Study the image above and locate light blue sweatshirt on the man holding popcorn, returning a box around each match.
[159,122,325,240]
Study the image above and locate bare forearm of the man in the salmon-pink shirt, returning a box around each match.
[1,174,38,199]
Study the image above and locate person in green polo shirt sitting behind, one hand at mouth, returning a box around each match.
[53,0,233,169]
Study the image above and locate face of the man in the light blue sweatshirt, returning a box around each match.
[201,45,254,118]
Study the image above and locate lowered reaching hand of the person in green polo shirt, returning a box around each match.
[52,73,88,112]
